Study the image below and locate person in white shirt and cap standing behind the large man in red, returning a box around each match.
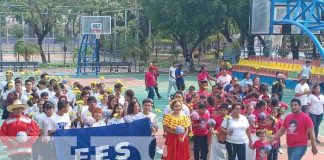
[295,75,310,114]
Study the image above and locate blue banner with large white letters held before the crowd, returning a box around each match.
[54,118,152,160]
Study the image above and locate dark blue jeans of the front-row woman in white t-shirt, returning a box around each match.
[225,142,246,160]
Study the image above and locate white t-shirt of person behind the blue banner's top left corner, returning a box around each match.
[47,113,71,131]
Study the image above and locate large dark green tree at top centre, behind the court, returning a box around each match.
[140,0,226,70]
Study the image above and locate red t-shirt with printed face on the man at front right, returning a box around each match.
[283,112,313,147]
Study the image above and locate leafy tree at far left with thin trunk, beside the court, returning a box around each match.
[2,0,68,63]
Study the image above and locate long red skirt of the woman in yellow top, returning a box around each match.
[162,133,190,160]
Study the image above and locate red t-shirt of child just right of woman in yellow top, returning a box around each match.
[192,110,210,136]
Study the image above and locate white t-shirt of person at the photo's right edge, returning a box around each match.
[308,94,324,115]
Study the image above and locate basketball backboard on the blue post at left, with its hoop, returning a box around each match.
[81,16,111,34]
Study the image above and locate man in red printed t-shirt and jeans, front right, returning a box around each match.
[273,98,318,160]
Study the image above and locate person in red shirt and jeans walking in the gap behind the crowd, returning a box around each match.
[145,66,156,100]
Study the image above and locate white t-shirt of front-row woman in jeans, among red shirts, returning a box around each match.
[221,115,250,144]
